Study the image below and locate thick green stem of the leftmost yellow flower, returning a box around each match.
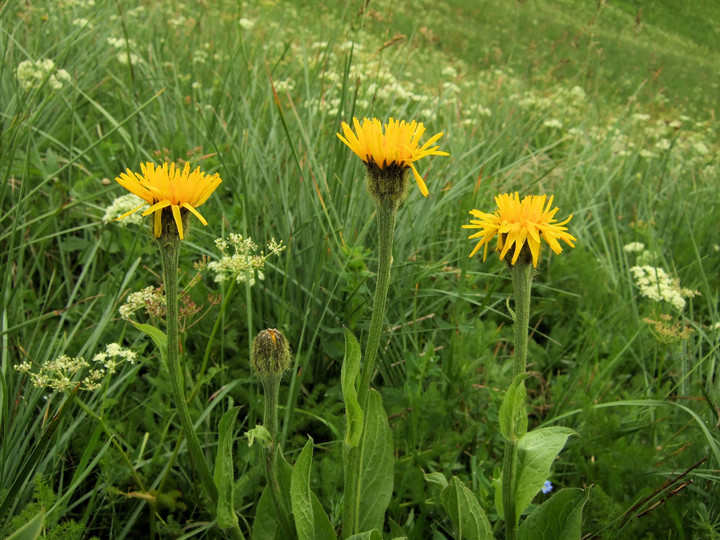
[159,234,244,538]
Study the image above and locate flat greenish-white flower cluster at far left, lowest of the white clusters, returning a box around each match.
[13,343,137,392]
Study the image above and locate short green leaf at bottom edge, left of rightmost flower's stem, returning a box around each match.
[440,476,493,540]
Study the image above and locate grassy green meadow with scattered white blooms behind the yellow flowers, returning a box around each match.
[0,0,720,539]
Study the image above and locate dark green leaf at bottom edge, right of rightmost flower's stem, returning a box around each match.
[518,488,590,540]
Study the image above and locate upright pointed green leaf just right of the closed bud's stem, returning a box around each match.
[290,437,336,540]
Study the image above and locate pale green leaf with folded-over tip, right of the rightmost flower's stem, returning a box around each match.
[515,426,575,523]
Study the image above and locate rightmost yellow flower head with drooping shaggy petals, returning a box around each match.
[463,192,577,267]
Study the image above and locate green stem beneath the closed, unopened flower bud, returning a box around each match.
[262,373,295,539]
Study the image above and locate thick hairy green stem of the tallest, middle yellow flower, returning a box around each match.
[343,201,397,538]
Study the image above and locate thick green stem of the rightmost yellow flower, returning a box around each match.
[502,261,533,540]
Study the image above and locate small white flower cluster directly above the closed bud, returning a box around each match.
[208,233,285,286]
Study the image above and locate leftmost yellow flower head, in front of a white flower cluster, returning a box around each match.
[115,162,222,240]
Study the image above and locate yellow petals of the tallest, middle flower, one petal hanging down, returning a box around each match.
[337,118,450,197]
